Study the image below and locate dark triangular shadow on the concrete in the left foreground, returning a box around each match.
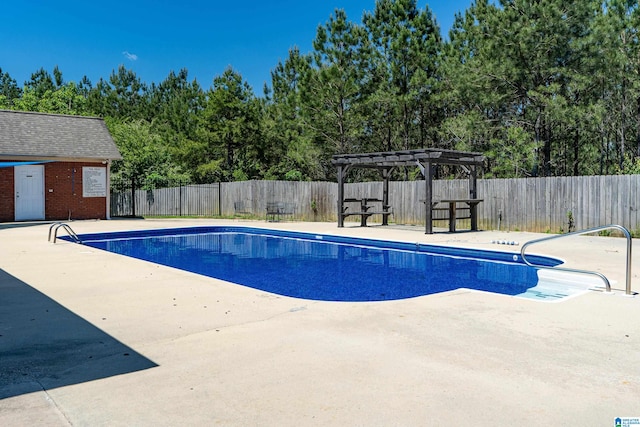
[0,270,158,399]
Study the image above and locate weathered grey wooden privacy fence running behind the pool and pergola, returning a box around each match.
[111,175,640,233]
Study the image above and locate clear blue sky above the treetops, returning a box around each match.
[0,0,472,95]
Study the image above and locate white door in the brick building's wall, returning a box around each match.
[14,165,44,221]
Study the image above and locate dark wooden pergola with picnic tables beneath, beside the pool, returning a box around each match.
[332,148,485,234]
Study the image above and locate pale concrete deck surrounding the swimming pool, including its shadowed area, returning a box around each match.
[0,220,640,426]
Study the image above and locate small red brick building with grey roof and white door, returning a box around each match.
[0,110,122,222]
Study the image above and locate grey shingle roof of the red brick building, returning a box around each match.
[0,110,122,160]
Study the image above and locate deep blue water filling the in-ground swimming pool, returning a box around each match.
[67,227,560,301]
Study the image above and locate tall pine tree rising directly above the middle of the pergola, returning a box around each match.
[363,0,441,150]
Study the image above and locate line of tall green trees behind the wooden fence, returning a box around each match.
[0,0,640,186]
